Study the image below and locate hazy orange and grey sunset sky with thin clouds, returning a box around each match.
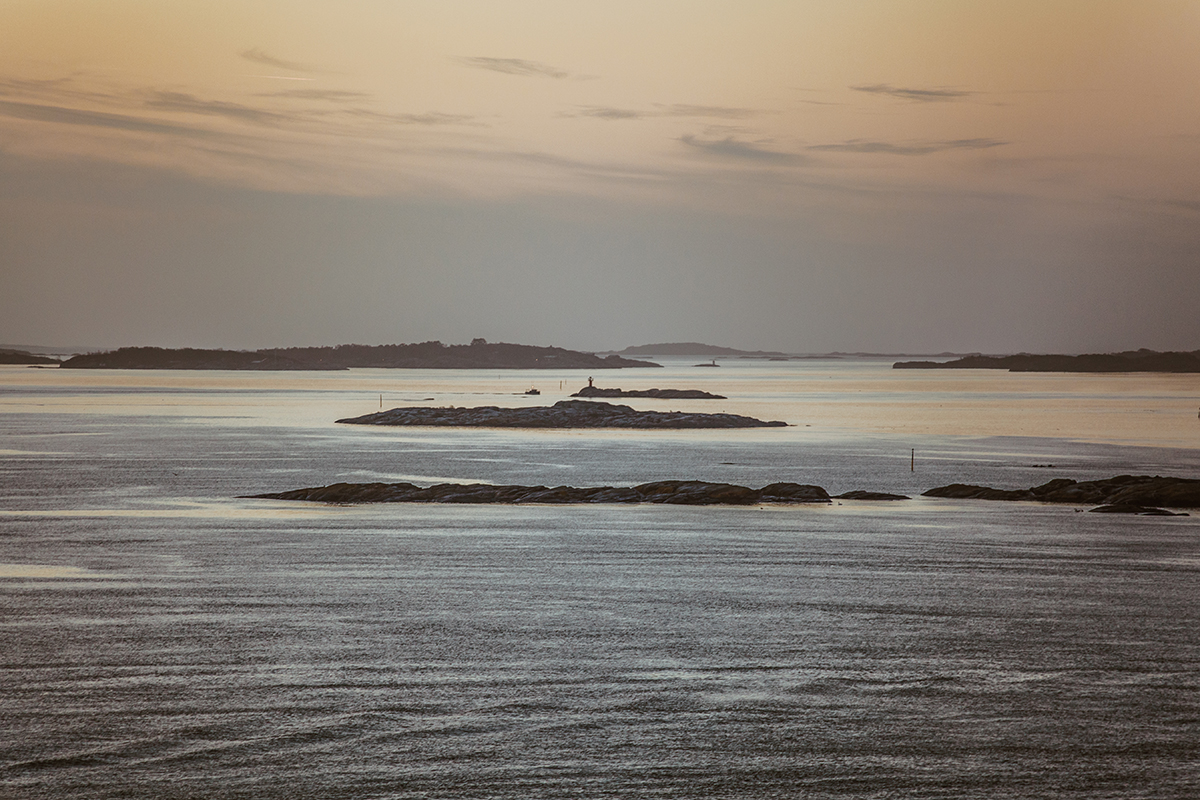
[0,0,1200,353]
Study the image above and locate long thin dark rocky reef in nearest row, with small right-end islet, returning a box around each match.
[246,481,907,506]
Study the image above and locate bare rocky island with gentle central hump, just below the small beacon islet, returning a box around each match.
[337,401,787,429]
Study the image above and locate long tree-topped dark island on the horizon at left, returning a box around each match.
[61,338,661,369]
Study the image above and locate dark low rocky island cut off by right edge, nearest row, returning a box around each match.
[922,475,1200,516]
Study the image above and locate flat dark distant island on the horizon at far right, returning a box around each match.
[892,349,1200,372]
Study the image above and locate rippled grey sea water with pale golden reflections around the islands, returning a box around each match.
[0,359,1200,798]
